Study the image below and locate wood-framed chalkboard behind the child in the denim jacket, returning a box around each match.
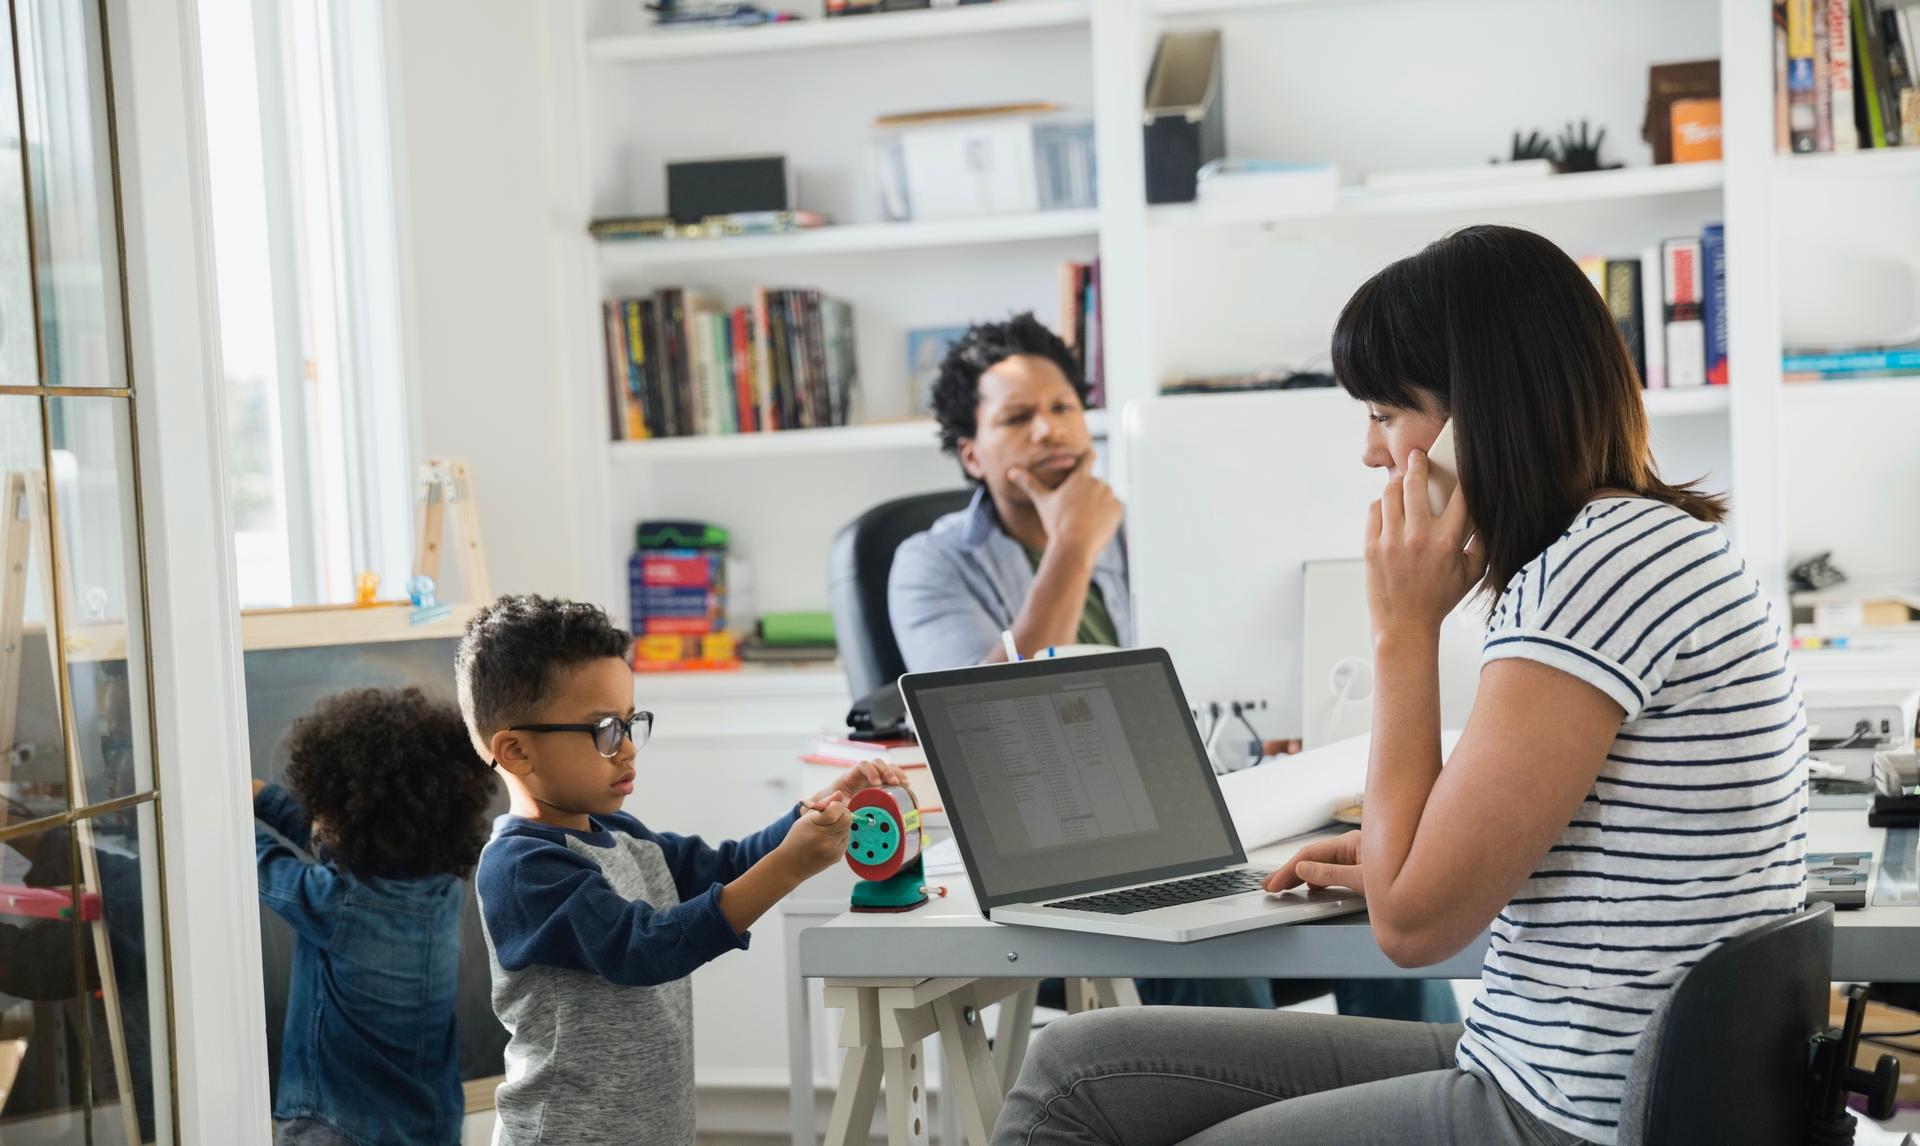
[246,637,507,1085]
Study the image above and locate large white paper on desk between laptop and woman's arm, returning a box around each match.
[1219,731,1459,850]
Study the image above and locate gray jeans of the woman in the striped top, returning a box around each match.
[993,1006,1580,1146]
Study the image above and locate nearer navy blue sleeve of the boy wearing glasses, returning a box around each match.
[474,835,747,987]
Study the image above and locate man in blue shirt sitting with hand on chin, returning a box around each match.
[887,313,1459,1023]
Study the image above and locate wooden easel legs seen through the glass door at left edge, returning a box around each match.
[0,470,152,1142]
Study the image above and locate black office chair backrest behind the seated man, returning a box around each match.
[828,489,973,701]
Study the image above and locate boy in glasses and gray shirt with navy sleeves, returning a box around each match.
[455,595,904,1146]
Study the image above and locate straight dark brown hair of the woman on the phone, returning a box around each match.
[1332,227,1726,595]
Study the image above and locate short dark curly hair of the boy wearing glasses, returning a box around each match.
[453,593,634,762]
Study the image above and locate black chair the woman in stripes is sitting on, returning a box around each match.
[1620,904,1899,1146]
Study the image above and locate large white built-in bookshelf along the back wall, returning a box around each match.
[555,0,1920,644]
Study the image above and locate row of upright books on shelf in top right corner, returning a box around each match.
[1774,0,1920,152]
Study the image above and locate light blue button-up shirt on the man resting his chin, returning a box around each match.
[887,486,1135,672]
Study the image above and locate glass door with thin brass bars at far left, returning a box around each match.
[0,0,177,1144]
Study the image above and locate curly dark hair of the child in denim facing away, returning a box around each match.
[286,689,493,879]
